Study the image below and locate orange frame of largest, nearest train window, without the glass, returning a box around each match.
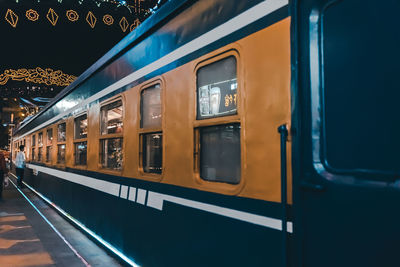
[192,49,246,195]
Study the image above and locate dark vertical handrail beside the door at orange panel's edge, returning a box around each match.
[278,124,288,267]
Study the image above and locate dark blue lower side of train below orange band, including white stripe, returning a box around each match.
[20,165,292,266]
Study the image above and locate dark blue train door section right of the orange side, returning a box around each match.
[292,0,400,267]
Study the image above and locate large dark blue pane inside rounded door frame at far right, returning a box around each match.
[321,1,400,175]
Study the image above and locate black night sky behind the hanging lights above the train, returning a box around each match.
[0,0,165,97]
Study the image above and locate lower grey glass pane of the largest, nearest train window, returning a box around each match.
[200,124,241,184]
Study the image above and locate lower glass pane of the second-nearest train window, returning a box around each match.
[142,133,162,174]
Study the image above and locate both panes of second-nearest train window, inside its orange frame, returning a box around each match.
[139,83,163,174]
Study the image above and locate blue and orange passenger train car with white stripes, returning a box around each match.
[12,0,400,267]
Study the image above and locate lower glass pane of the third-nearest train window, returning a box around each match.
[100,138,123,170]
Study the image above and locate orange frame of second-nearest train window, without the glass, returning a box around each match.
[136,76,162,182]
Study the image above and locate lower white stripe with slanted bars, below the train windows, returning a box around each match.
[26,164,293,233]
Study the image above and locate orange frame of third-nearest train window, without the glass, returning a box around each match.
[97,94,126,174]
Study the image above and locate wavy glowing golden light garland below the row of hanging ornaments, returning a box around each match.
[0,67,76,86]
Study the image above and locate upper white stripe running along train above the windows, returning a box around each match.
[15,0,289,141]
